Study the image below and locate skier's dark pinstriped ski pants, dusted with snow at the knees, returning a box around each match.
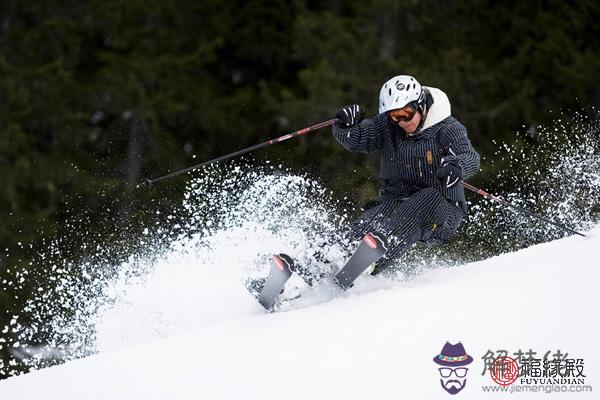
[350,188,464,271]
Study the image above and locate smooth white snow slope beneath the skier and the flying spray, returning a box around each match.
[0,228,600,399]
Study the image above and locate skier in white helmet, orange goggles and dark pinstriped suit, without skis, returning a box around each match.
[333,75,479,275]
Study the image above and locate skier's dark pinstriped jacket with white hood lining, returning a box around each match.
[333,88,479,212]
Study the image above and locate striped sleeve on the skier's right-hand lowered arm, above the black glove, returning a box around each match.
[441,121,479,179]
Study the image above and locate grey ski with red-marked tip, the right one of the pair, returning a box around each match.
[334,232,388,289]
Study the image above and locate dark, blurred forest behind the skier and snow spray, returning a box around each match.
[0,0,600,376]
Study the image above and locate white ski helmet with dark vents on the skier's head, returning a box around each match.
[379,75,425,114]
